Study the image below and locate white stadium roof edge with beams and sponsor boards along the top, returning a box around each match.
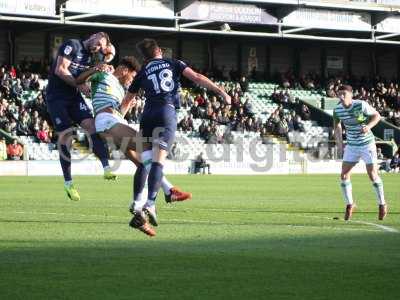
[0,0,400,45]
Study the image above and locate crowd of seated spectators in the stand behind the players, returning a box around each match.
[0,60,400,163]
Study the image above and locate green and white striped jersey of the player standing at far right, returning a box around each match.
[333,100,376,146]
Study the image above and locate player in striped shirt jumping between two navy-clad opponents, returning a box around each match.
[76,57,192,235]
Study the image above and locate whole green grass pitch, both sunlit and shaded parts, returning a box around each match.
[0,174,400,300]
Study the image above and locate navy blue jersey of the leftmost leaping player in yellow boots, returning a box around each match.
[47,39,92,98]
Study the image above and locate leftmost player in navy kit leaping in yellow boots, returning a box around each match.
[46,32,116,201]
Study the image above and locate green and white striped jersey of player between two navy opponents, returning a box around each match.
[90,72,125,115]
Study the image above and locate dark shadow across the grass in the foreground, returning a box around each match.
[0,232,400,300]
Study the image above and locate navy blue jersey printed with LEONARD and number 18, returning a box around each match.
[129,58,187,108]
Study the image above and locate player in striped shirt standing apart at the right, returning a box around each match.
[333,85,387,220]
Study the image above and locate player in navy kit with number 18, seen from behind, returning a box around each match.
[126,39,231,234]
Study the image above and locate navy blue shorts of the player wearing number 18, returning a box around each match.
[140,104,177,151]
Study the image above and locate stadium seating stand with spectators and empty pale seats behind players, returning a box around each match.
[0,63,400,164]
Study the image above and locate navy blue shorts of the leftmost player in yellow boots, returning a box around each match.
[46,94,93,132]
